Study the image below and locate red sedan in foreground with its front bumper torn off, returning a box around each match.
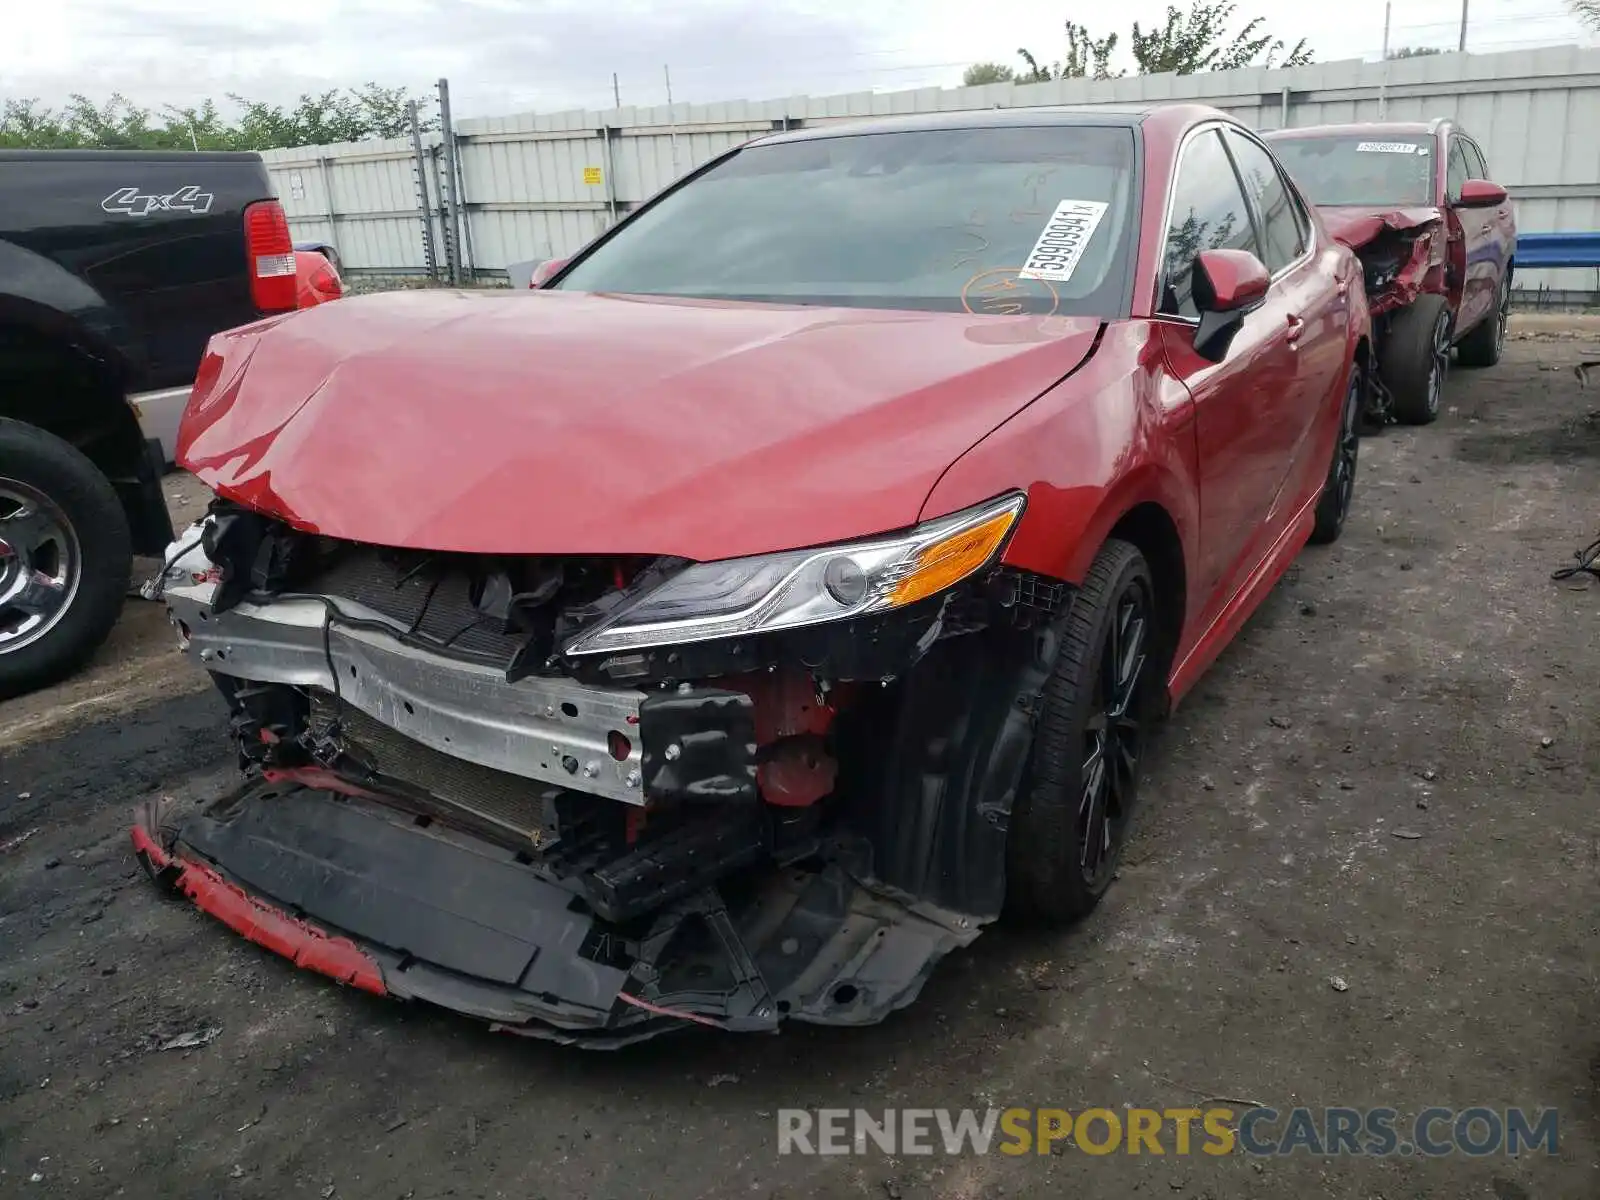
[134,107,1370,1046]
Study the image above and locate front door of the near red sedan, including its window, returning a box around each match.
[1158,123,1304,629]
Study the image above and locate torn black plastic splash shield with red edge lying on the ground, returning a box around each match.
[133,781,978,1048]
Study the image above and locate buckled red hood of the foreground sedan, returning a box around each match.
[178,291,1099,560]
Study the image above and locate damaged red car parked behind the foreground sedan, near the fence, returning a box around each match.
[1267,120,1517,426]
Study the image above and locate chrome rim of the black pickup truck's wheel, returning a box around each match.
[0,477,83,654]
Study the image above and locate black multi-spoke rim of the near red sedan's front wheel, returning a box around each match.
[1077,579,1152,888]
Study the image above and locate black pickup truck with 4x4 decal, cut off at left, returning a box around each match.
[0,150,294,699]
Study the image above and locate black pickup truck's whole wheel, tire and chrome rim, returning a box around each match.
[0,419,133,699]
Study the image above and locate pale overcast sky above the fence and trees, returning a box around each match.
[0,0,1594,117]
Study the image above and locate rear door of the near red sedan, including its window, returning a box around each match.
[1224,128,1352,534]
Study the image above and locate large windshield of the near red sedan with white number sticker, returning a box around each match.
[555,125,1136,317]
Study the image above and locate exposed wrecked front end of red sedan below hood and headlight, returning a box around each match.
[133,512,1067,1046]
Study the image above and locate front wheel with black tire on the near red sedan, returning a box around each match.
[1006,539,1162,922]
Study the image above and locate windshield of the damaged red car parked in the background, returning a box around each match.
[1272,133,1434,206]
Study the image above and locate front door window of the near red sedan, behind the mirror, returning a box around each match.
[1160,130,1261,317]
